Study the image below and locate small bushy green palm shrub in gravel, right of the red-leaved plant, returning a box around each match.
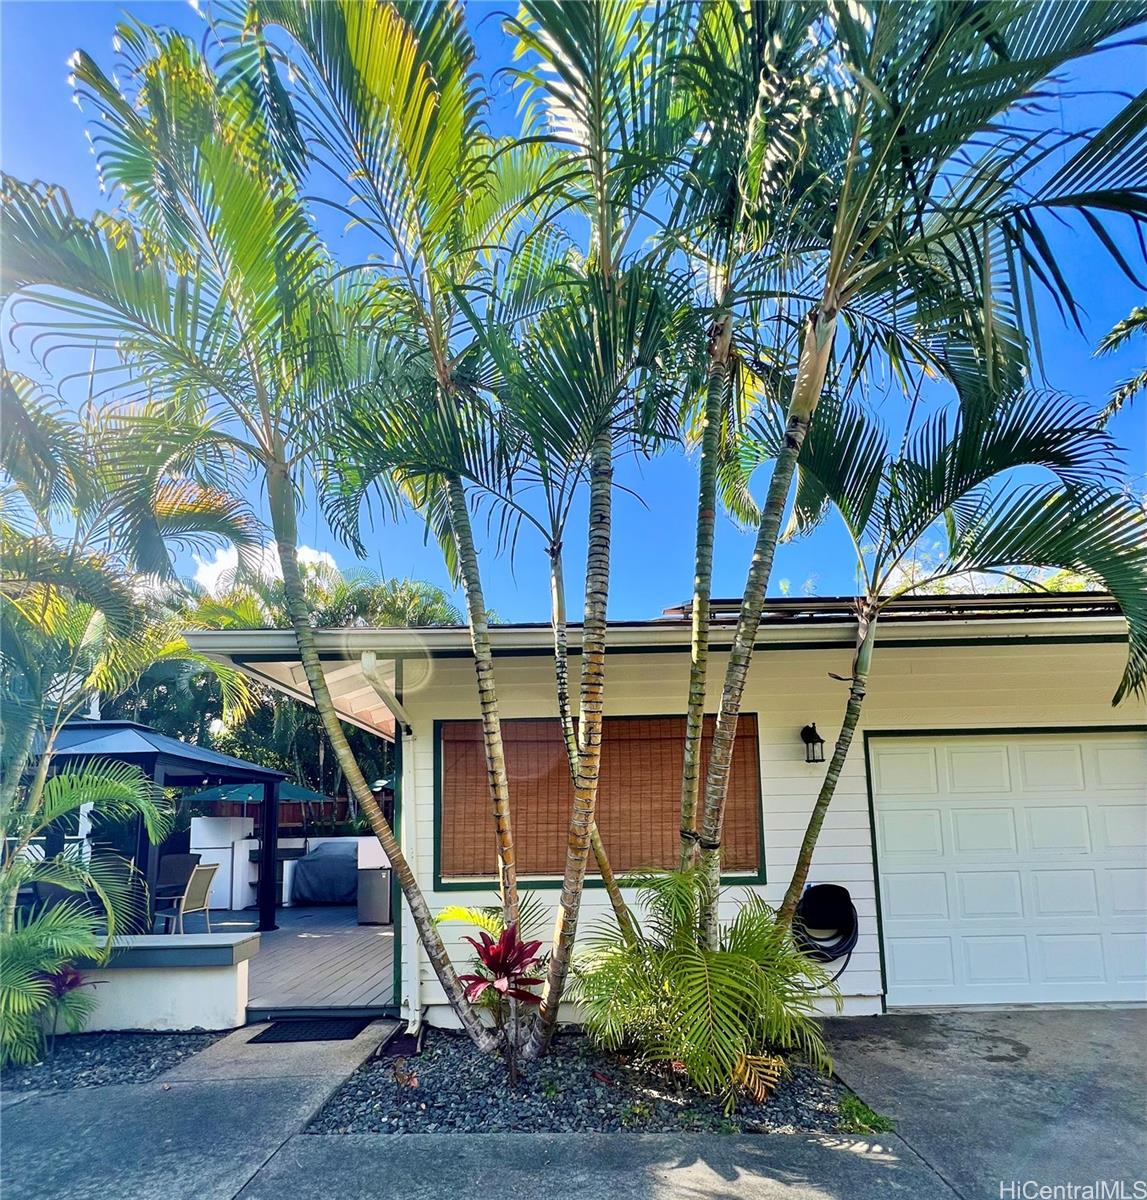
[572,869,840,1111]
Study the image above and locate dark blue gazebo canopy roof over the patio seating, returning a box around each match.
[53,719,286,798]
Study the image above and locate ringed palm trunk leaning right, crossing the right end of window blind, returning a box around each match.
[701,302,836,949]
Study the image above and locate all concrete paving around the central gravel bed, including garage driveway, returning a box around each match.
[11,1009,1147,1200]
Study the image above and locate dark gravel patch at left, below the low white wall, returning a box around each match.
[0,1033,224,1092]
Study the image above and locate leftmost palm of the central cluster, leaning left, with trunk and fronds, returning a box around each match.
[4,18,494,1048]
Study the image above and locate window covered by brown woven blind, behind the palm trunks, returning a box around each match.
[438,715,761,880]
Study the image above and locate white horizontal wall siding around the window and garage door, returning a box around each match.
[402,631,1145,1024]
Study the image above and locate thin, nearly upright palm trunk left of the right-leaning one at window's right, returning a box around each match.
[680,313,733,871]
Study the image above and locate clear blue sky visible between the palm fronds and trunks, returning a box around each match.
[0,0,1147,620]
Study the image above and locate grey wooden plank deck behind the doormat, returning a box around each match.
[211,906,395,1019]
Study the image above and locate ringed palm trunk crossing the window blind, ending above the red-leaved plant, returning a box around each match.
[445,475,518,925]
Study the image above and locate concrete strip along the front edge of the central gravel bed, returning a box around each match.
[240,1133,957,1200]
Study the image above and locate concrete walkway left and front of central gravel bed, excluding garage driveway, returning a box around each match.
[0,1022,956,1200]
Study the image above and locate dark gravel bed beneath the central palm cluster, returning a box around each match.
[307,1030,841,1134]
